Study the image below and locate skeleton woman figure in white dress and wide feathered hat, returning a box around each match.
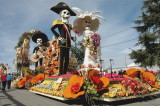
[72,7,103,69]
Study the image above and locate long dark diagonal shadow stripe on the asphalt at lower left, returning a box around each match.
[1,91,25,106]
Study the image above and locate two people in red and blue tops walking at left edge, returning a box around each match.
[0,73,12,91]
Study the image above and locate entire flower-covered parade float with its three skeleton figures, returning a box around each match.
[10,2,160,105]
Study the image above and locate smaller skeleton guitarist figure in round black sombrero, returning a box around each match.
[31,31,48,68]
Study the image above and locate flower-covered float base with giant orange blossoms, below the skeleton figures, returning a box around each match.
[30,68,160,101]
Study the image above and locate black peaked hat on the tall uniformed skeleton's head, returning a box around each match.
[50,2,76,16]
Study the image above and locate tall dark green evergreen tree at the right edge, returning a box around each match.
[129,0,160,67]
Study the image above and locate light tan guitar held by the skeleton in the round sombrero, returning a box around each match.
[30,51,47,63]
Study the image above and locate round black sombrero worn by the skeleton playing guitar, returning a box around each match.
[32,32,48,43]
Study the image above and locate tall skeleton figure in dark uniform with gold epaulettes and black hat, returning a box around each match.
[51,2,76,75]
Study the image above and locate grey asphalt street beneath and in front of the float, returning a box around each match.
[0,89,160,106]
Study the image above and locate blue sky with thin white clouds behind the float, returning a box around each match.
[0,0,144,69]
